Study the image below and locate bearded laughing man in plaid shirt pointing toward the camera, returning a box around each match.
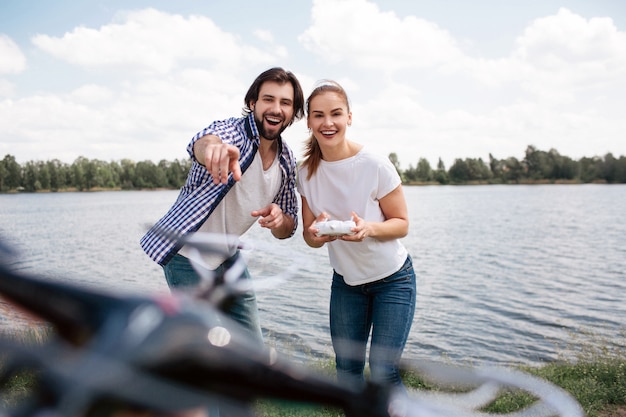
[141,68,304,341]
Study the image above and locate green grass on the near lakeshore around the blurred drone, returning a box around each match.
[0,324,626,417]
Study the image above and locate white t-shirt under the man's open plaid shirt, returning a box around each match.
[178,152,281,269]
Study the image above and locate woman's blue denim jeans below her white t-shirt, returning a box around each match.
[330,256,417,386]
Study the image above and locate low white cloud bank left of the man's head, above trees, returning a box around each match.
[0,66,247,161]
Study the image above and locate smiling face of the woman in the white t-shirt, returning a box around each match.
[307,91,352,148]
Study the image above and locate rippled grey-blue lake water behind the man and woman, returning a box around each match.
[0,184,626,365]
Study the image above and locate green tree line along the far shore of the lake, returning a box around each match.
[0,146,626,192]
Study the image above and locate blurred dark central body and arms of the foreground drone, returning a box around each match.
[0,260,384,416]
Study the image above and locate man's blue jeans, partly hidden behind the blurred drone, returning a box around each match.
[163,252,263,343]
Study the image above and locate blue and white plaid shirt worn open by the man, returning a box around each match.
[140,114,298,265]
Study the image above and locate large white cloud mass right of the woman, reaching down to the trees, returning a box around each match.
[300,0,626,166]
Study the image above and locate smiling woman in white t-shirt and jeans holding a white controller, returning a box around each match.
[298,81,416,386]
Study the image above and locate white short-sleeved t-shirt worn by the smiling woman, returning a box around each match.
[298,148,408,285]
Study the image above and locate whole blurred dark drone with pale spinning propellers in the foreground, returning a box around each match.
[0,234,584,417]
